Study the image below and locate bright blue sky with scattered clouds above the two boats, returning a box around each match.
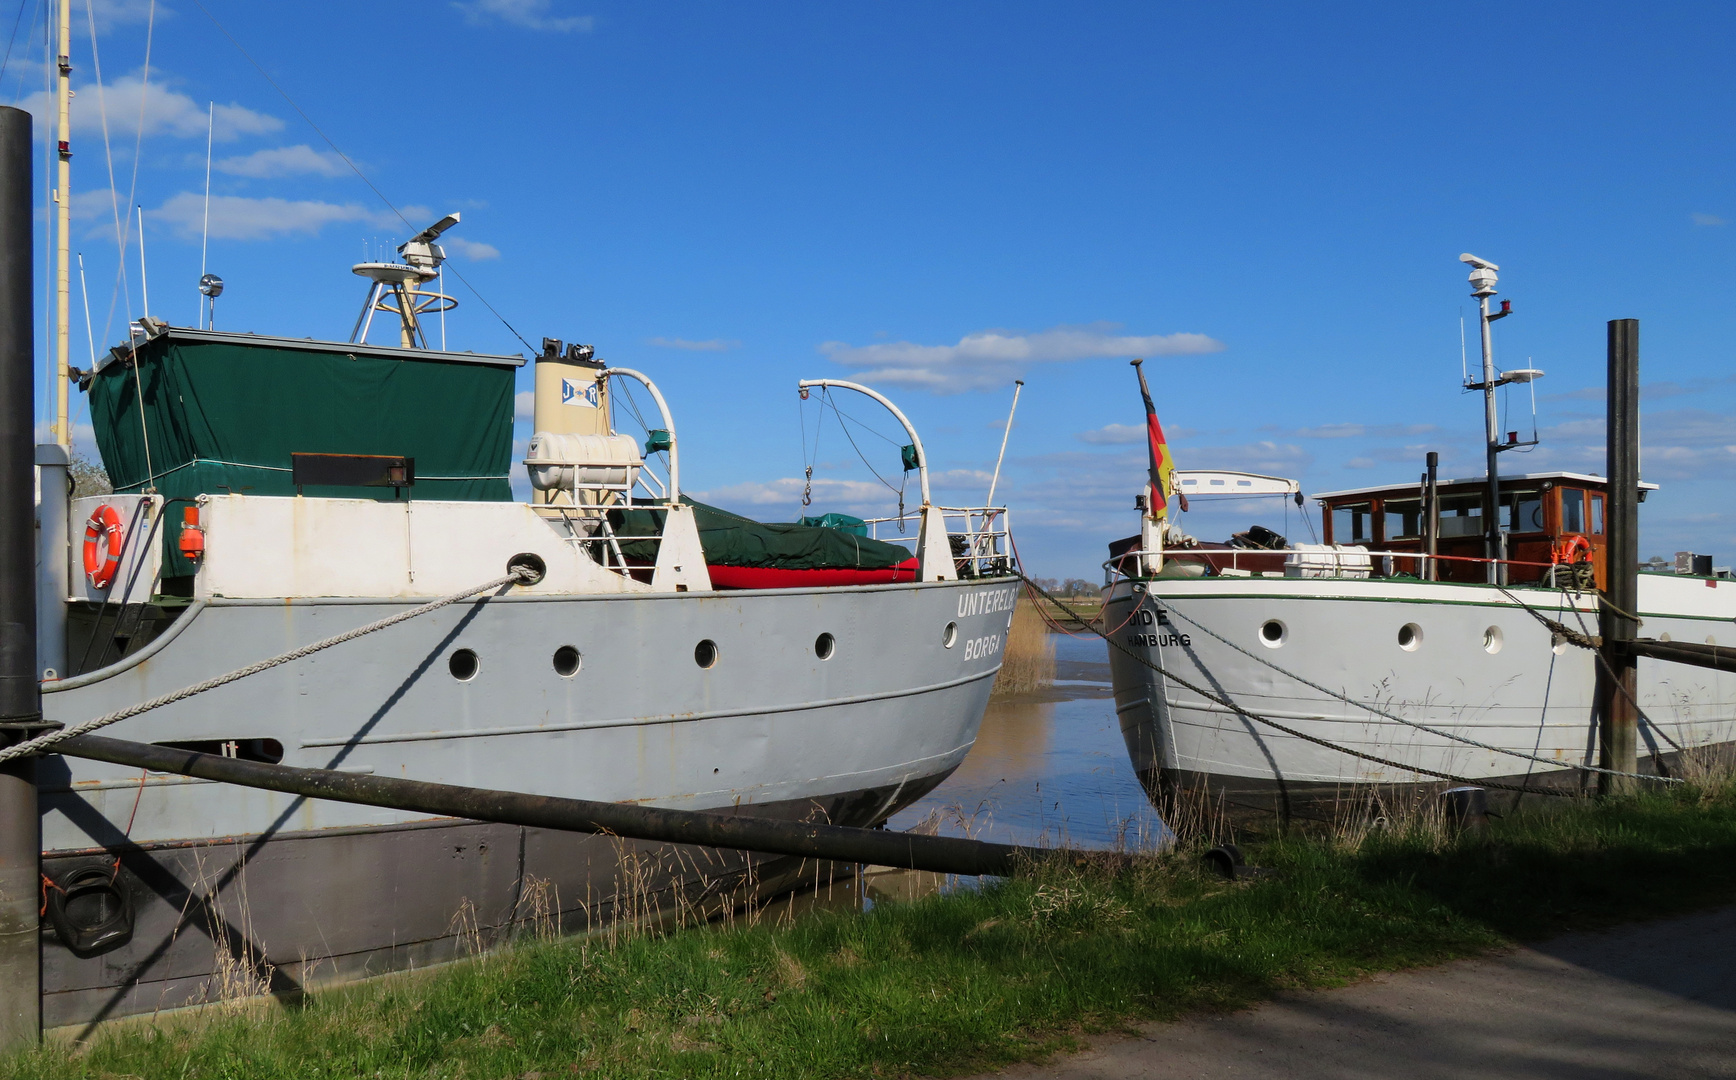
[16,0,1736,578]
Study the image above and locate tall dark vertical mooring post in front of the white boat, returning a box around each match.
[1597,319,1639,794]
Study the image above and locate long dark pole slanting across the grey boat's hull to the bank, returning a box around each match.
[64,734,1043,877]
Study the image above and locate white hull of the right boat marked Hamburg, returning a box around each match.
[1106,576,1736,816]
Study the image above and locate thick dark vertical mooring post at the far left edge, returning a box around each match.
[0,108,42,1052]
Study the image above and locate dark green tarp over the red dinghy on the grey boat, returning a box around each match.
[609,495,911,570]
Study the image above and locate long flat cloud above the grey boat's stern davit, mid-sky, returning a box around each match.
[819,323,1224,394]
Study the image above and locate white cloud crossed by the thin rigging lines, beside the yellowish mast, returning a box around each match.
[19,73,283,144]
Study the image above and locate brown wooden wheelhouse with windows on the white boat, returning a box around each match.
[1314,472,1658,589]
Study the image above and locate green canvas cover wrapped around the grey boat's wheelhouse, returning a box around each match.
[90,330,516,576]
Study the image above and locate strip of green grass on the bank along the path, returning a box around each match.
[10,792,1736,1080]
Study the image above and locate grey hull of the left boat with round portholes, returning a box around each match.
[40,582,1014,1026]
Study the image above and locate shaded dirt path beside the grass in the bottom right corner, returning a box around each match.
[996,908,1736,1080]
